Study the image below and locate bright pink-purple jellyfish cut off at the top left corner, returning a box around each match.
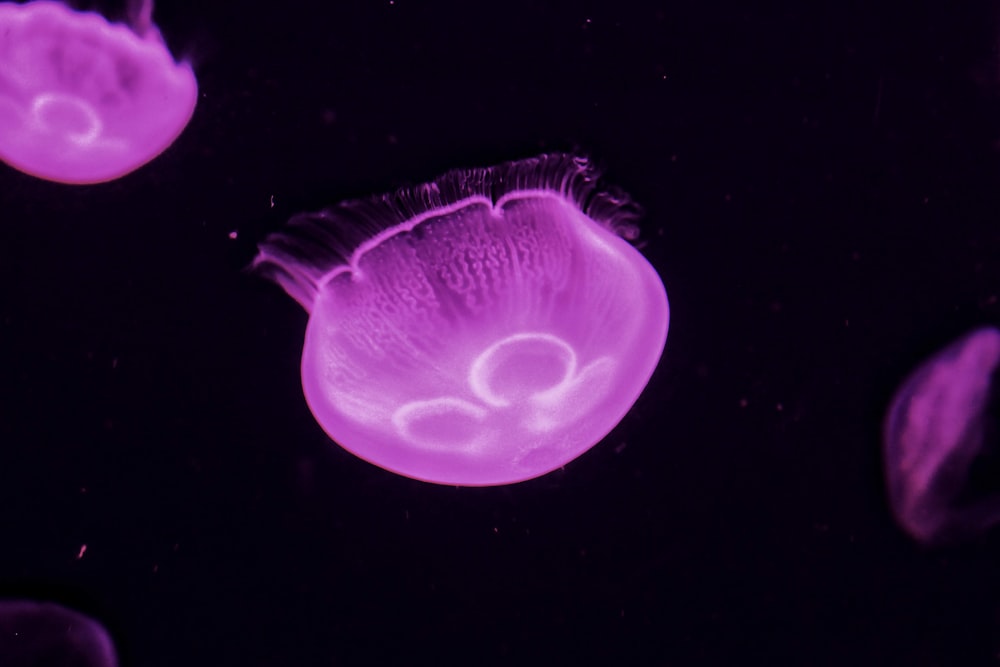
[0,0,198,184]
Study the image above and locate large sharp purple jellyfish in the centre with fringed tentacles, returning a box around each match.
[254,154,669,486]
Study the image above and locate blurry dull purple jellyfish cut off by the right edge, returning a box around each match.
[883,327,1000,545]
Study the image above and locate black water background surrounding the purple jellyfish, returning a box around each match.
[0,0,1000,667]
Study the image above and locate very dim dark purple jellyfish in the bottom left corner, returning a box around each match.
[0,600,118,667]
